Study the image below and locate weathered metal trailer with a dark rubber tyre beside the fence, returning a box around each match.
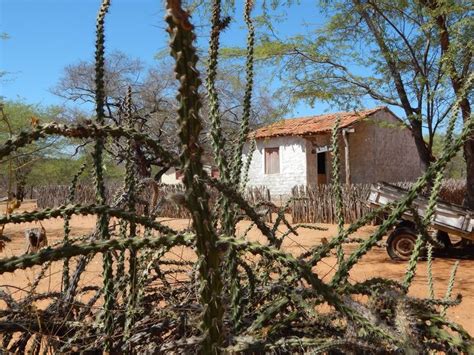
[367,183,474,260]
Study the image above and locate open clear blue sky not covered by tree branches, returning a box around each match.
[0,0,340,116]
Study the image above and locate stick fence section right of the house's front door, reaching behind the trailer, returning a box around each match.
[291,179,466,223]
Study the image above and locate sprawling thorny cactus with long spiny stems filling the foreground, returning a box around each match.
[0,0,474,354]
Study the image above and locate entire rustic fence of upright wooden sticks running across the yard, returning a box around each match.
[4,179,466,223]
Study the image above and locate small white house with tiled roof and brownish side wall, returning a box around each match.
[243,107,422,198]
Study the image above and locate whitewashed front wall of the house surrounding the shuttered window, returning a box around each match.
[243,137,307,199]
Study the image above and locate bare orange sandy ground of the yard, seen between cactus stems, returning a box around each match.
[0,202,474,334]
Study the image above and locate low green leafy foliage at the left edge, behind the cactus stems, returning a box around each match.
[0,101,123,197]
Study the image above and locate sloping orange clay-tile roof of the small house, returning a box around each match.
[251,106,389,138]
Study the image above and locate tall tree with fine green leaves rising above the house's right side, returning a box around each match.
[225,0,474,206]
